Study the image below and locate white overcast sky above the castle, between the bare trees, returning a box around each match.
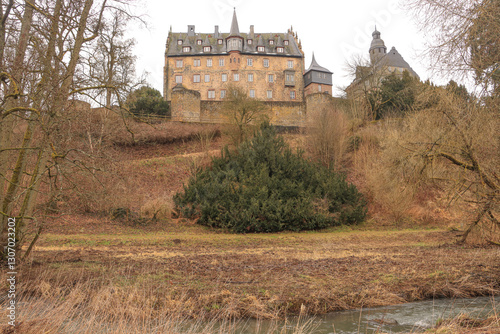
[131,0,439,95]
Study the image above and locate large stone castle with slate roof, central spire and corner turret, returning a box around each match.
[163,11,332,126]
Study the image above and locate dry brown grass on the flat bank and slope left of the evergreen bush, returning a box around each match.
[0,119,500,333]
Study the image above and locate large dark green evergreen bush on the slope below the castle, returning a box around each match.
[174,125,366,233]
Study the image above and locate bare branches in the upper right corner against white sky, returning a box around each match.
[406,0,500,96]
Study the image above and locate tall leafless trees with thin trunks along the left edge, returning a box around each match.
[0,0,141,258]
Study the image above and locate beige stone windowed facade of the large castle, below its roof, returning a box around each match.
[164,53,304,102]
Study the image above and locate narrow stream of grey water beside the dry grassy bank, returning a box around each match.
[236,296,500,334]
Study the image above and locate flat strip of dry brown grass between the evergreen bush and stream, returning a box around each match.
[2,220,500,332]
